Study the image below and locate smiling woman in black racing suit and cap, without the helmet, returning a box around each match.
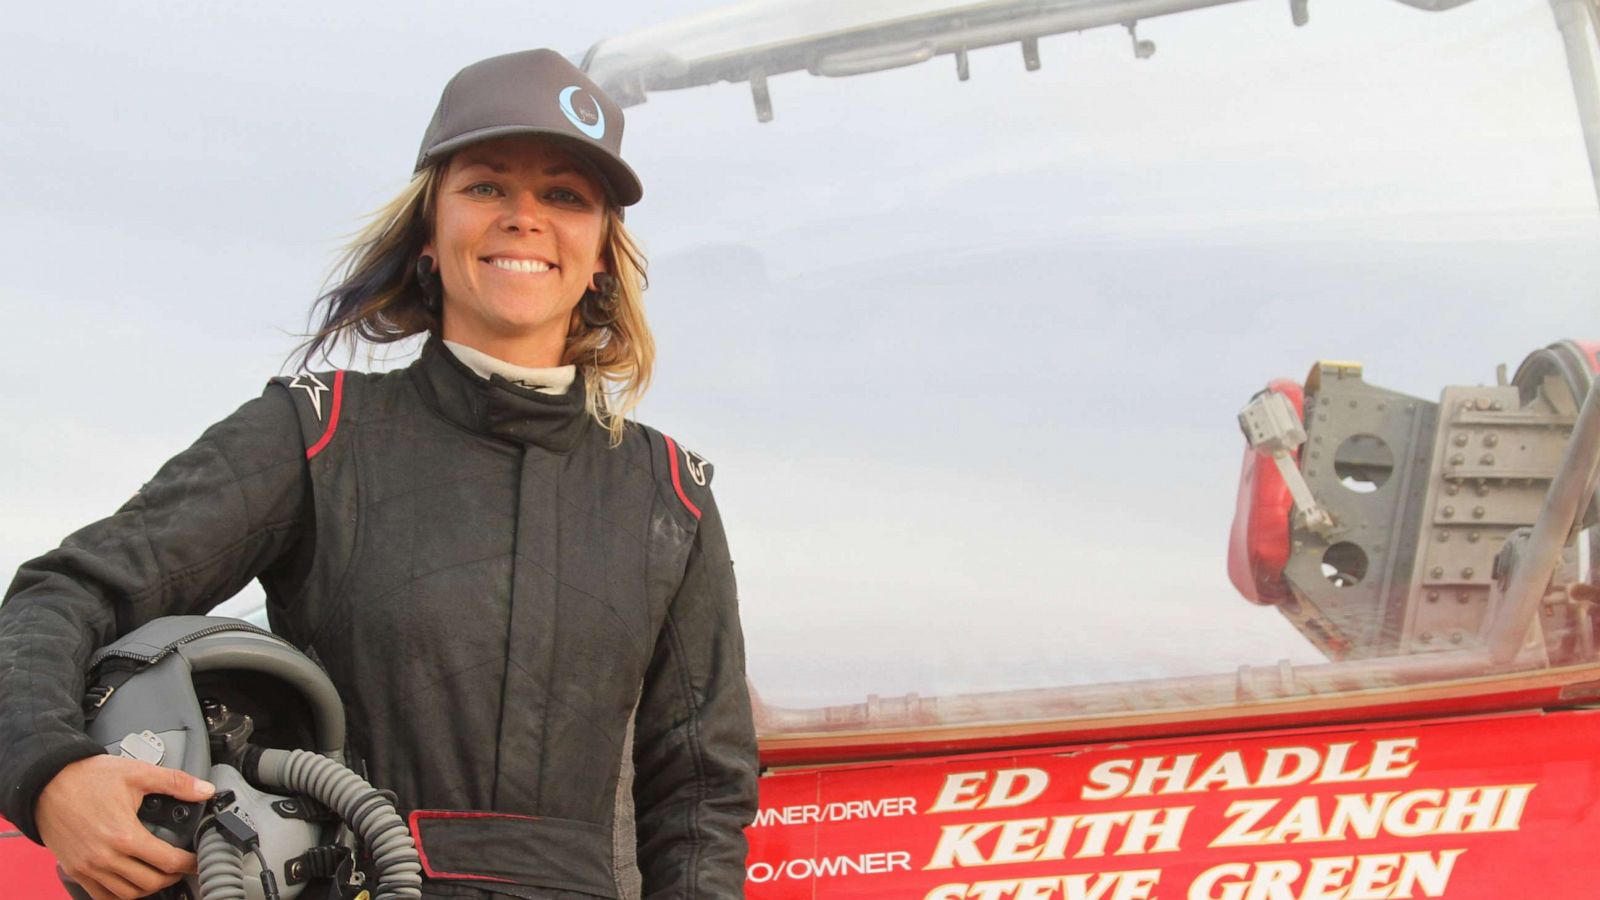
[0,50,755,898]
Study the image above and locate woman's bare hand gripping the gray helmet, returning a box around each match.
[34,756,216,900]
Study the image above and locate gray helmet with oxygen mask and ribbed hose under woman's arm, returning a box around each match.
[67,615,421,900]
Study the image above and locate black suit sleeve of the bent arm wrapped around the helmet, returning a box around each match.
[0,386,310,841]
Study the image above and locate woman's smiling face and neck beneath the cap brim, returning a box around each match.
[422,138,605,365]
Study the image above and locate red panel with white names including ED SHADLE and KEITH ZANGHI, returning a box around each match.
[747,711,1600,900]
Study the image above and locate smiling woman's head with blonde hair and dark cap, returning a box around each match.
[301,71,656,442]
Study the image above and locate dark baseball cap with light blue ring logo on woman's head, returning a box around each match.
[416,50,645,207]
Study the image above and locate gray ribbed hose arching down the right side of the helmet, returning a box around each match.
[254,749,422,900]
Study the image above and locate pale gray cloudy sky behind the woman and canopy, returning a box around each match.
[0,0,1600,705]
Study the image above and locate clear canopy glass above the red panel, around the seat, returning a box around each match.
[587,0,1600,735]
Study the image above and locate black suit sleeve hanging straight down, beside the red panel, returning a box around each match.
[634,493,757,900]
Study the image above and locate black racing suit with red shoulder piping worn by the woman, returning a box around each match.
[0,341,757,900]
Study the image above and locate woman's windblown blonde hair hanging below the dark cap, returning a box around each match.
[298,163,656,447]
